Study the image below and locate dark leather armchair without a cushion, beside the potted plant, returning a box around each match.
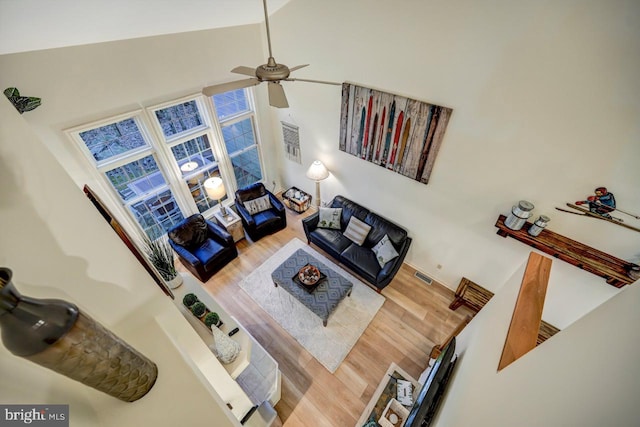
[168,214,238,282]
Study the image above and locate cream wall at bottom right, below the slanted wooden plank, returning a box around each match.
[434,261,640,427]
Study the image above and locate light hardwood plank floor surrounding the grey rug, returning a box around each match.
[179,209,470,427]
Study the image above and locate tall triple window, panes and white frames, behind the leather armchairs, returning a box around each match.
[67,89,263,239]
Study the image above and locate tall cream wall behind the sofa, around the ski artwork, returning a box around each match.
[271,0,640,327]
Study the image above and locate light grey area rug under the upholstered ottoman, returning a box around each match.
[240,239,384,373]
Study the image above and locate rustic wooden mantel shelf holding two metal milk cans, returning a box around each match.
[496,215,636,288]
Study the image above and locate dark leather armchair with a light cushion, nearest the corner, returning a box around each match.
[236,182,287,242]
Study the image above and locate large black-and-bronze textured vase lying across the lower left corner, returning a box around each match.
[0,268,158,402]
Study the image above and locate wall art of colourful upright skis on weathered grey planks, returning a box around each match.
[340,83,453,184]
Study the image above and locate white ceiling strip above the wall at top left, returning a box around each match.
[0,0,290,54]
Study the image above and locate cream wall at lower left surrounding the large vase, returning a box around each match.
[0,97,239,427]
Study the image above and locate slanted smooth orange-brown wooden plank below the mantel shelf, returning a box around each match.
[498,252,551,371]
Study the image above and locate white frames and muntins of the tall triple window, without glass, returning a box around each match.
[69,88,266,242]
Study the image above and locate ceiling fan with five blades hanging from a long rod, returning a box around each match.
[202,0,341,108]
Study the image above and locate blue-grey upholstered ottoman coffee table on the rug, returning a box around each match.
[271,249,353,326]
